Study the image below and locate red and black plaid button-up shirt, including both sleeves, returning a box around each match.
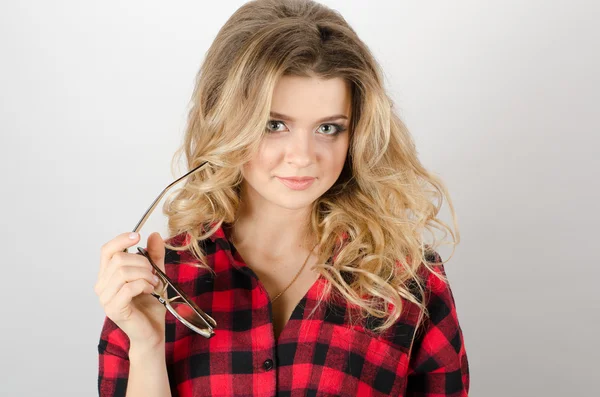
[98,224,469,397]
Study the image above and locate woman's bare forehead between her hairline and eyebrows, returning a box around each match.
[271,76,352,120]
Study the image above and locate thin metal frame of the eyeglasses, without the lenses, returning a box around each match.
[123,161,217,339]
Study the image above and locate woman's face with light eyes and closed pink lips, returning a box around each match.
[242,76,352,210]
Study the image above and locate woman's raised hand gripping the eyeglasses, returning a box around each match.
[94,233,166,350]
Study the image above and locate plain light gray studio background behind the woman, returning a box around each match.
[0,0,600,397]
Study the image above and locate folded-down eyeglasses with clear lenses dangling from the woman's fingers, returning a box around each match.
[123,161,217,338]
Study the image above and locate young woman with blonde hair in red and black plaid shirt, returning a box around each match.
[95,0,469,397]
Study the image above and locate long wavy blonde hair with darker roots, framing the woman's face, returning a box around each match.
[163,0,459,332]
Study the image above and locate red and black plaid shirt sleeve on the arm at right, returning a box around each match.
[406,264,469,397]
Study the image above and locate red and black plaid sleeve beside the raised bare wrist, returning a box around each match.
[98,317,129,397]
